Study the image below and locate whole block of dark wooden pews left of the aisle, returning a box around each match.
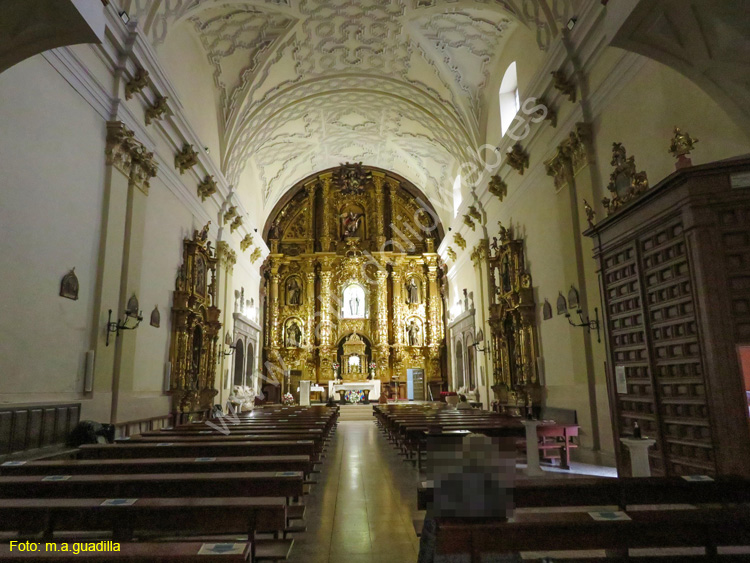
[0,406,339,562]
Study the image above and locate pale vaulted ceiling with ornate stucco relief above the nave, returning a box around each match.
[129,0,567,221]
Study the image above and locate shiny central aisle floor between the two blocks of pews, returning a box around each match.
[290,416,419,563]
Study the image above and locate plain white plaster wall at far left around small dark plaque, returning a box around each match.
[0,56,105,402]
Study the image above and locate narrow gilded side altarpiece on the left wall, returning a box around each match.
[169,223,221,412]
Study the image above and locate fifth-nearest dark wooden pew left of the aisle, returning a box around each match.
[78,438,317,461]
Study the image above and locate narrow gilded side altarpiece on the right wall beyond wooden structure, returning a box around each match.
[487,224,542,415]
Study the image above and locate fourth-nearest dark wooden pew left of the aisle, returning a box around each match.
[0,455,314,475]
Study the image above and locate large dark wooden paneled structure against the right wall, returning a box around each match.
[585,159,750,475]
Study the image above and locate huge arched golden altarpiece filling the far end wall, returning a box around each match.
[263,164,445,399]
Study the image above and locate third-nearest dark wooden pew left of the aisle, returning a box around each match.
[0,471,304,502]
